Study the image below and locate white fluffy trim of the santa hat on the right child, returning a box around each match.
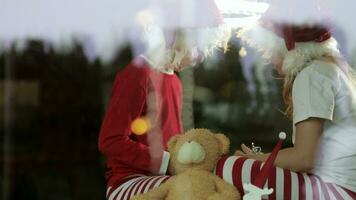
[237,24,340,75]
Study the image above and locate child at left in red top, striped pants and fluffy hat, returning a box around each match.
[99,1,229,200]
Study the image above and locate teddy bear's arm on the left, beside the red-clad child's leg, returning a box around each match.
[131,178,173,200]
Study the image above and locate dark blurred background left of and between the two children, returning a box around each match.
[0,36,291,200]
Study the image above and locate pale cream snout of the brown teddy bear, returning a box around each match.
[177,140,205,164]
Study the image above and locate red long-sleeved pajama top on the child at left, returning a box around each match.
[99,58,183,186]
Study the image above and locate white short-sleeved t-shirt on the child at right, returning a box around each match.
[292,61,356,191]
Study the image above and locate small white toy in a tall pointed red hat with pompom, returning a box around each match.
[243,132,287,200]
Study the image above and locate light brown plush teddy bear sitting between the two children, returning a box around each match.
[133,129,241,200]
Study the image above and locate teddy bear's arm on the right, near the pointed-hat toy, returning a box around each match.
[208,176,241,200]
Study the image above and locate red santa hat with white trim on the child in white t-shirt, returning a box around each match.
[238,0,340,75]
